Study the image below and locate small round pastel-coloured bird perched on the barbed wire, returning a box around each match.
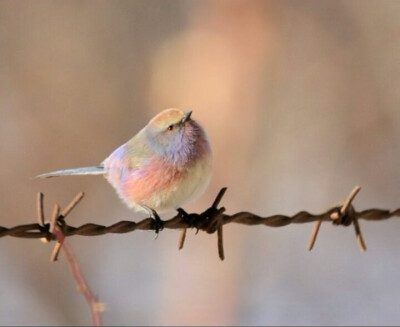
[36,108,213,234]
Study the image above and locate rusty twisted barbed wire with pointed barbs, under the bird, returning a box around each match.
[0,186,400,260]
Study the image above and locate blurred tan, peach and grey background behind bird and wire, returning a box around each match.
[0,0,400,325]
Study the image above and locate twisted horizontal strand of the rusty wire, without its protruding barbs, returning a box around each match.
[0,206,400,239]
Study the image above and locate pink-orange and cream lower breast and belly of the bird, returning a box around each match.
[106,146,212,211]
